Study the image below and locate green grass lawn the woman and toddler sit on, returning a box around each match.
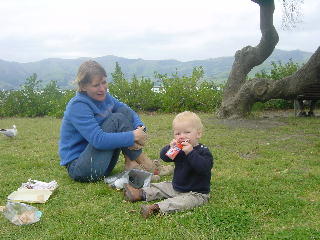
[0,114,320,239]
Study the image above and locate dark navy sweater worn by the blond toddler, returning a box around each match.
[160,144,213,194]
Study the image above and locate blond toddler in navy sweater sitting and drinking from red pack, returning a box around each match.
[124,111,213,218]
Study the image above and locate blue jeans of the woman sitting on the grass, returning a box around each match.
[67,107,142,182]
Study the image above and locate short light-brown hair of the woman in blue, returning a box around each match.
[74,60,107,92]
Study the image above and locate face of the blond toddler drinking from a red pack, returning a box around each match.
[173,121,201,146]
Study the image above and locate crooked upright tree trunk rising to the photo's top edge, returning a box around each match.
[218,0,279,118]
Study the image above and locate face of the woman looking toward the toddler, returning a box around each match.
[81,75,108,101]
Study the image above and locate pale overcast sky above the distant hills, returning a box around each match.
[0,0,320,62]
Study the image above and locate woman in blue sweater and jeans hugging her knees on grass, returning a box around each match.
[59,60,169,182]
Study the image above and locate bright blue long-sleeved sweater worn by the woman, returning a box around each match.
[59,92,144,166]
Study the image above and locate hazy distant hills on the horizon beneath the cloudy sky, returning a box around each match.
[0,49,312,89]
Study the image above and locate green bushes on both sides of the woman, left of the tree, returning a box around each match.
[0,63,222,117]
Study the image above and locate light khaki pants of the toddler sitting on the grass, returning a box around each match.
[143,182,209,213]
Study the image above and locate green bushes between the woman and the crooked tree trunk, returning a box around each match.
[109,63,222,112]
